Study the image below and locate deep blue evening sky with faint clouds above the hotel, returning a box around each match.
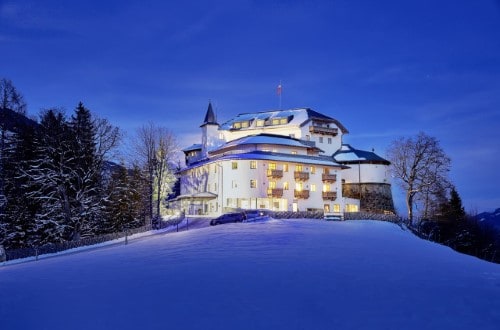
[0,0,500,211]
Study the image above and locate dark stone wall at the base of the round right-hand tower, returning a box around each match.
[342,183,395,213]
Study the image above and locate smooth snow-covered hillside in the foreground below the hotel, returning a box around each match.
[0,220,500,330]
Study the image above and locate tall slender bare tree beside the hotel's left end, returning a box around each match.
[132,123,177,226]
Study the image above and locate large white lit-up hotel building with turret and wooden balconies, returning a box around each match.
[171,103,393,217]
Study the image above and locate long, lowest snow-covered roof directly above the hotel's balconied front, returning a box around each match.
[180,150,344,172]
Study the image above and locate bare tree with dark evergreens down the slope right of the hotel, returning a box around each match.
[387,132,500,262]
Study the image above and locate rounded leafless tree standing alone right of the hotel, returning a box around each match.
[387,132,451,221]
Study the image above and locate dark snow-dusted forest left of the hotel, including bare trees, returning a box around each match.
[0,79,175,249]
